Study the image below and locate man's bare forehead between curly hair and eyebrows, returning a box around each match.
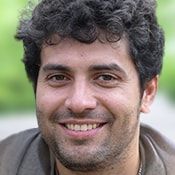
[41,39,135,73]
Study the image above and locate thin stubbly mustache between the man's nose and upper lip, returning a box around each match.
[45,110,114,123]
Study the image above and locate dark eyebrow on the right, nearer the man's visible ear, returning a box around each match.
[89,63,127,75]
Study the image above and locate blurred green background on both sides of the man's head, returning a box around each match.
[0,0,175,113]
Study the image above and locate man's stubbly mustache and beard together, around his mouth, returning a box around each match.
[37,108,138,172]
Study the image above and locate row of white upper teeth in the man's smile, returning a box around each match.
[65,124,99,131]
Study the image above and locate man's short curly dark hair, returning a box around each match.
[15,0,164,90]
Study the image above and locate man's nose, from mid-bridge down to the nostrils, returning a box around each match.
[65,82,97,113]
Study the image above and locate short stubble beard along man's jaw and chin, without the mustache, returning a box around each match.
[37,110,138,172]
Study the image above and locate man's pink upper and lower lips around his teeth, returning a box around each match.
[59,120,107,140]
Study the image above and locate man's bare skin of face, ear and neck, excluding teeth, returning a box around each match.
[36,39,157,175]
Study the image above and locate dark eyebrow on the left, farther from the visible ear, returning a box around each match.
[42,64,72,72]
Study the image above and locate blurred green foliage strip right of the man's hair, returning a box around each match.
[157,0,175,102]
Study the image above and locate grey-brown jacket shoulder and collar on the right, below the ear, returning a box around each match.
[140,124,175,175]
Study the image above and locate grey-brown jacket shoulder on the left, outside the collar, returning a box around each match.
[0,129,47,175]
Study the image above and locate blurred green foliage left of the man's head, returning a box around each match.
[0,0,34,112]
